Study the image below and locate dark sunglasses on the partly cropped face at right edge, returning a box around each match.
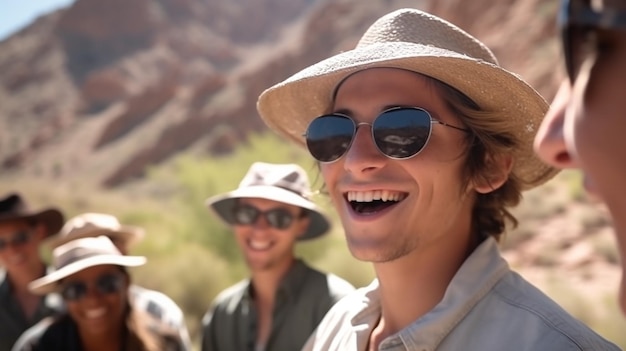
[558,0,626,83]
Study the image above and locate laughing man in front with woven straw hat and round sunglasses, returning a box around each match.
[257,9,618,351]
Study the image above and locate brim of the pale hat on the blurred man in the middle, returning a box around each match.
[205,185,330,241]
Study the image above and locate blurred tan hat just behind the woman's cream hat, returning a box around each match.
[44,213,145,248]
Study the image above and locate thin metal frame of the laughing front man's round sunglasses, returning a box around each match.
[302,106,471,163]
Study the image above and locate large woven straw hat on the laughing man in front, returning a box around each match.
[257,9,558,189]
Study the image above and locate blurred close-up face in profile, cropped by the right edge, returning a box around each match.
[535,0,626,309]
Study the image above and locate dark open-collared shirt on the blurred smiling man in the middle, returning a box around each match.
[202,260,354,351]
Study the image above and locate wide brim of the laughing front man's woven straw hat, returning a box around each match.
[257,42,558,190]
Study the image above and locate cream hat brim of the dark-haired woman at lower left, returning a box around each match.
[28,255,146,295]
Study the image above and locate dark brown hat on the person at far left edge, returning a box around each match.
[0,193,64,235]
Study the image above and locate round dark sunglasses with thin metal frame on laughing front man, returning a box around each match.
[304,107,468,162]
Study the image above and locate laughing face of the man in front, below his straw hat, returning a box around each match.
[321,68,475,262]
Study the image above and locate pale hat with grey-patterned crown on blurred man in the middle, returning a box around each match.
[206,162,330,240]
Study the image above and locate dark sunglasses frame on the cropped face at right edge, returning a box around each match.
[558,0,626,83]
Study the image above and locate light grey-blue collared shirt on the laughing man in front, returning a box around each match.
[303,238,619,351]
